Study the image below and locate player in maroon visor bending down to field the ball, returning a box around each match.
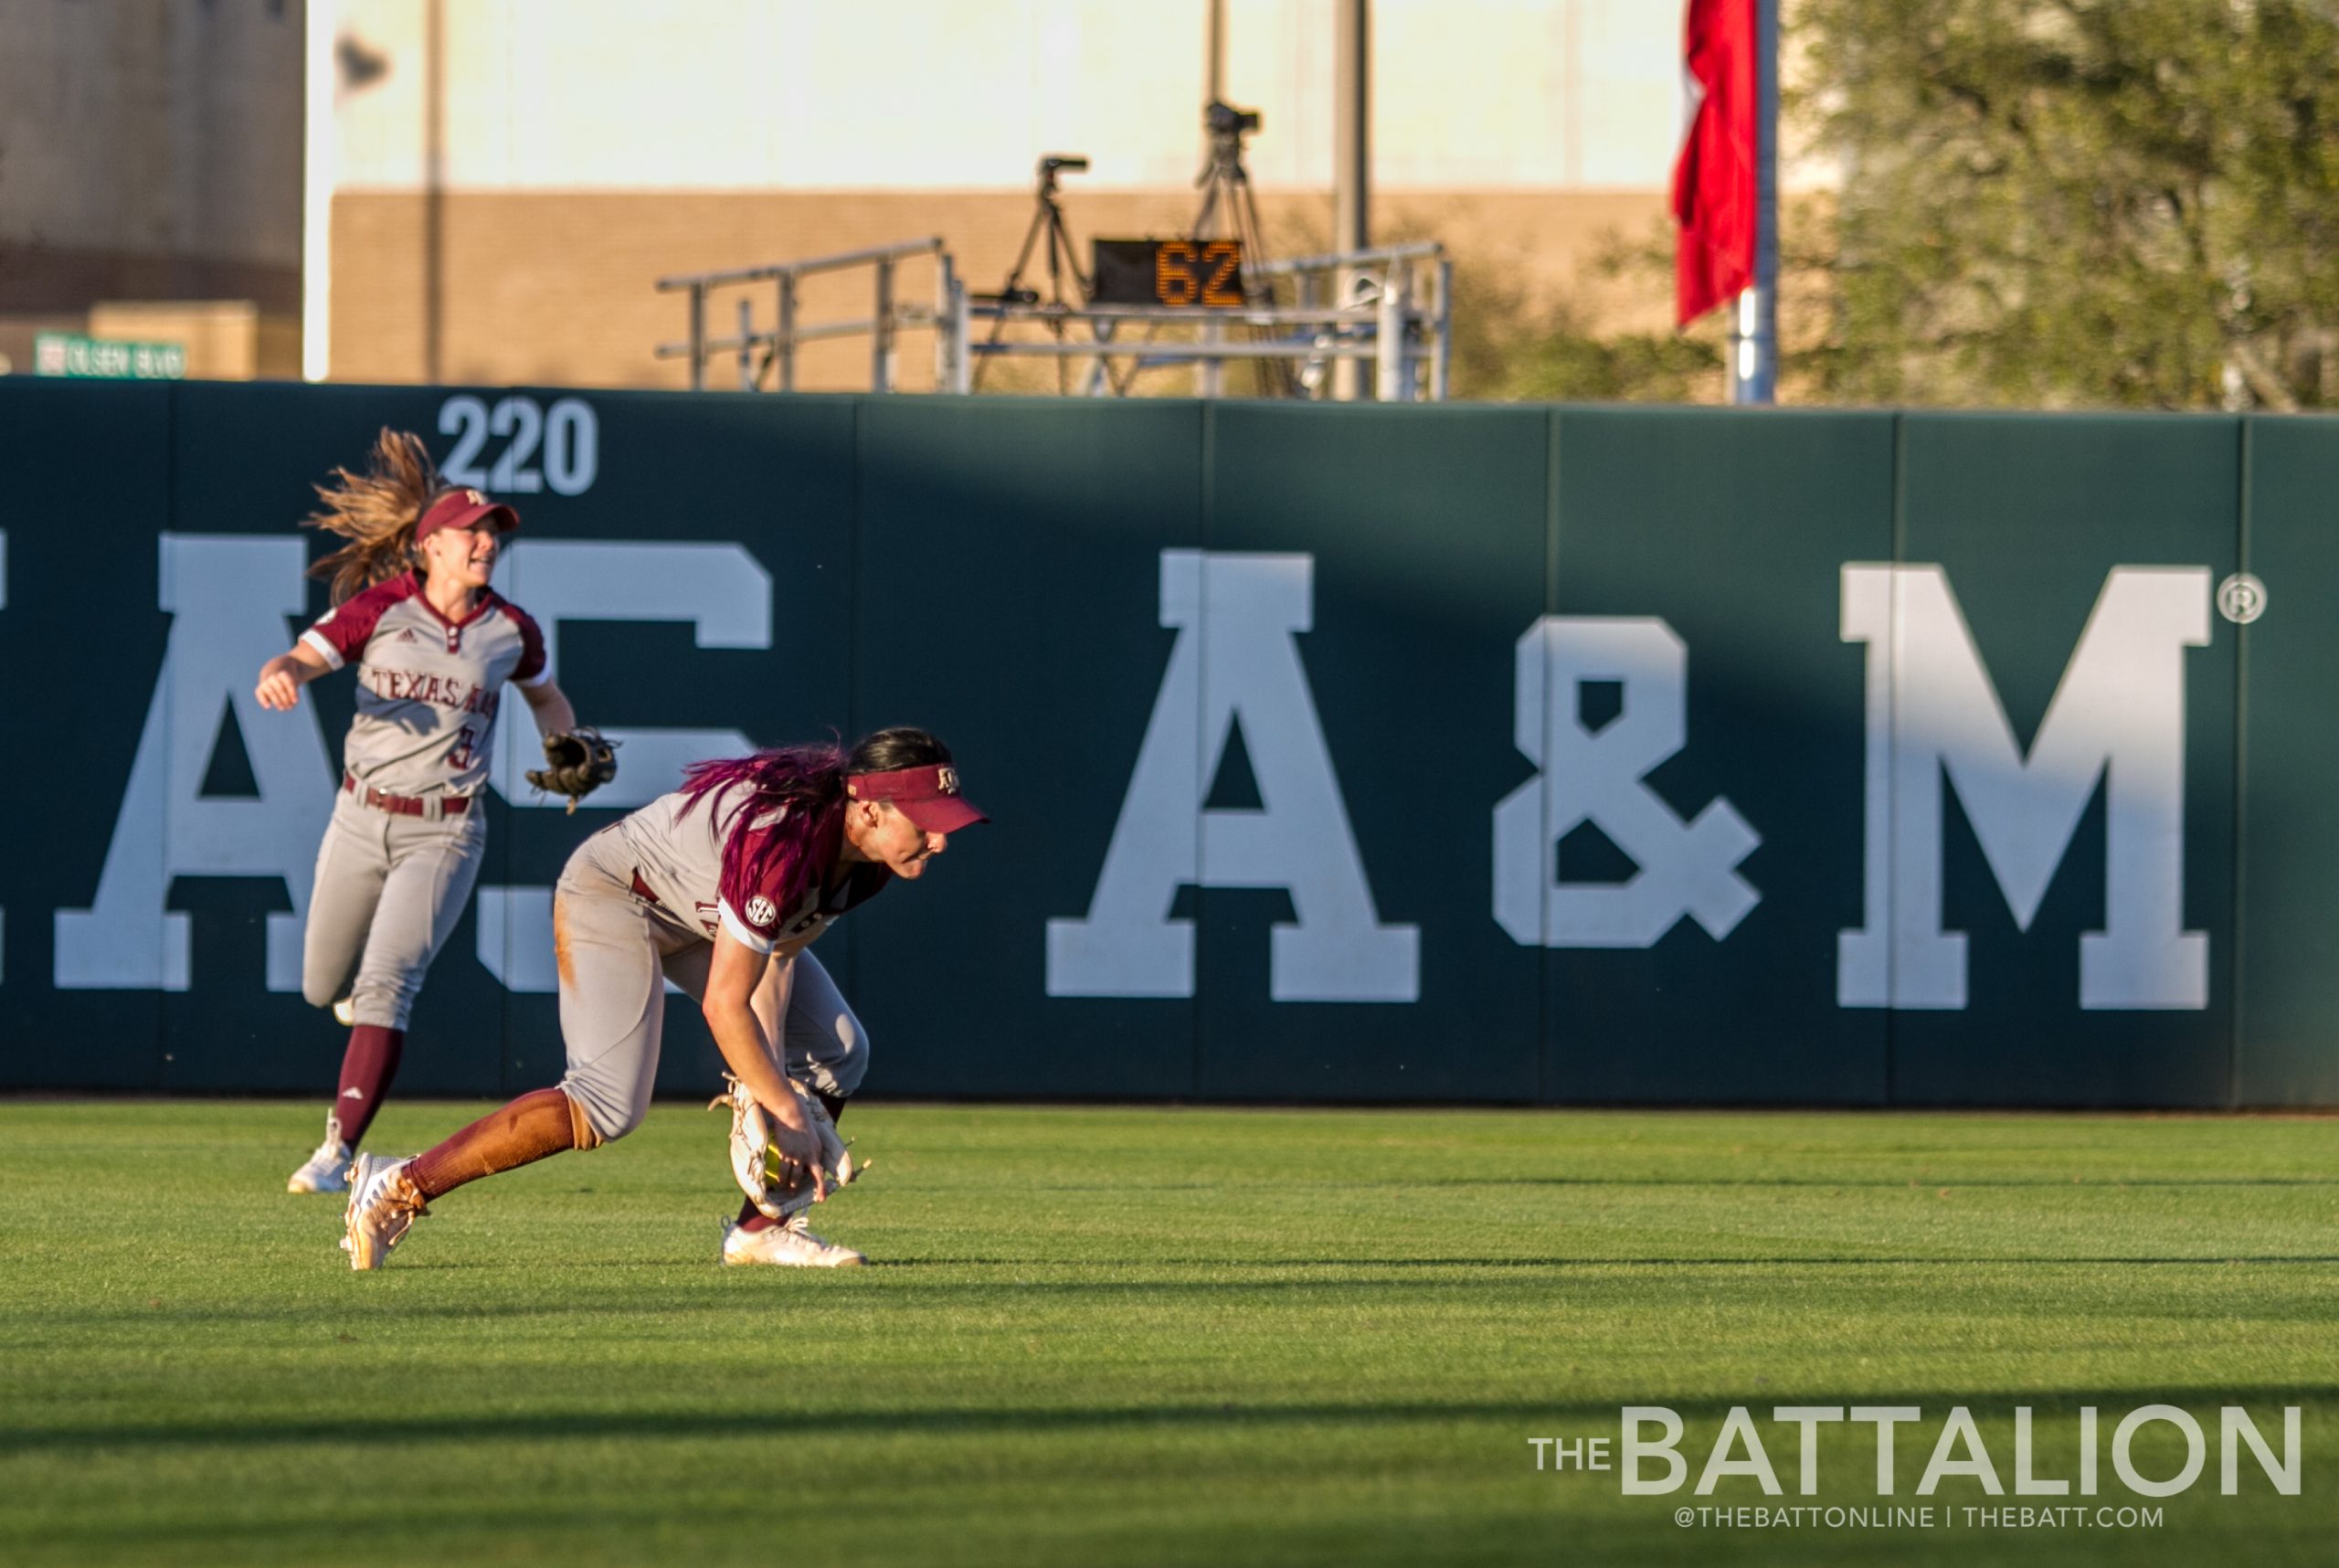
[342,728,985,1268]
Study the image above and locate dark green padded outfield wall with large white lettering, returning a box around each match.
[0,379,2339,1107]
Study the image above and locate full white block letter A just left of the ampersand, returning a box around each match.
[1048,550,1420,1001]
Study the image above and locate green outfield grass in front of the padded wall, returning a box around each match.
[0,1102,2339,1568]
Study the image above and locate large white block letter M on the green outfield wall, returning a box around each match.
[1836,564,2210,1009]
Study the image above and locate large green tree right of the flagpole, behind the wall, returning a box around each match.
[1787,0,2339,409]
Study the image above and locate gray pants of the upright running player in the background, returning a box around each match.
[300,789,486,1030]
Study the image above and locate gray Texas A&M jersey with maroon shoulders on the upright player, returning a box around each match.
[302,571,550,796]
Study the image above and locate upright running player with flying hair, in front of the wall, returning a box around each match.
[258,430,615,1192]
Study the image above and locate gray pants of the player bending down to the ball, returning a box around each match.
[552,831,870,1142]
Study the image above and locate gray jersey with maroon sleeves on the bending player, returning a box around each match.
[608,787,894,952]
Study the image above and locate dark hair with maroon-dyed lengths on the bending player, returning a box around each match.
[683,726,949,927]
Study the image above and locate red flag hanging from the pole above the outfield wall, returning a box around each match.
[1672,0,1762,328]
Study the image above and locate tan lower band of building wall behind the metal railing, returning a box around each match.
[333,192,1663,391]
